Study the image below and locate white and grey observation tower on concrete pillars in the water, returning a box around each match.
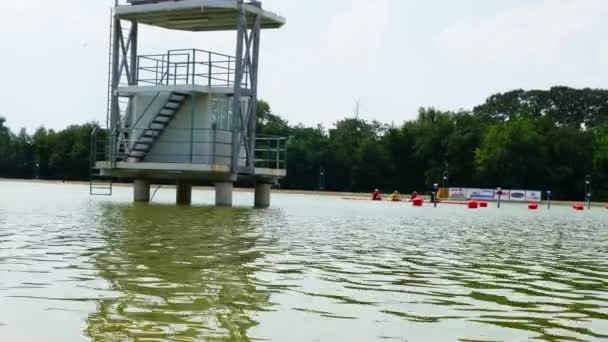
[91,0,286,207]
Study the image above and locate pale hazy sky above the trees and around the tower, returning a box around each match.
[0,0,608,132]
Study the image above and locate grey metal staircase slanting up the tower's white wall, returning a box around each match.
[125,92,189,163]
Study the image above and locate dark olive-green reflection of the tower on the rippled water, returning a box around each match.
[86,205,269,341]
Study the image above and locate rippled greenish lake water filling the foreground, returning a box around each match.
[0,182,608,342]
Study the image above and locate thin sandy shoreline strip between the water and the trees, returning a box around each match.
[0,178,606,208]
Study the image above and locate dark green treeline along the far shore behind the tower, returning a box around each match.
[0,87,608,200]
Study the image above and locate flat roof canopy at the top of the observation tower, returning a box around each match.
[115,0,285,31]
